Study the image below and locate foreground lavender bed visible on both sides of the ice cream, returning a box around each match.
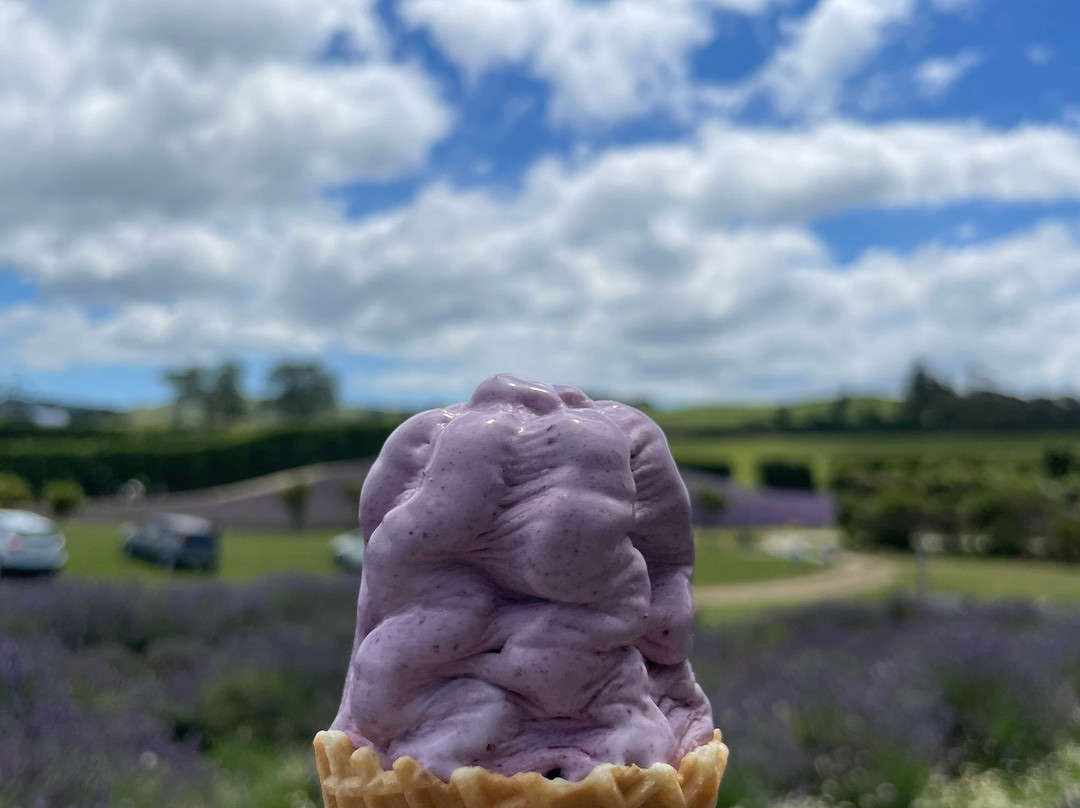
[0,579,1080,808]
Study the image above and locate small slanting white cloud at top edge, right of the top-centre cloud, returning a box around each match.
[753,0,917,118]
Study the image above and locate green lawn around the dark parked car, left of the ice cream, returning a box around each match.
[64,522,341,583]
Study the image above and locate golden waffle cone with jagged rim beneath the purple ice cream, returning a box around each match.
[315,729,728,808]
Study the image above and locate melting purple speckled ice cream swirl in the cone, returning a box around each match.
[332,375,713,780]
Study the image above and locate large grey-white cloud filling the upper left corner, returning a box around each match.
[0,0,450,230]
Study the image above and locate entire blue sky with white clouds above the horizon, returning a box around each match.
[0,0,1080,405]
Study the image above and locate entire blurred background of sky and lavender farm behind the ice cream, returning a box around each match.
[0,0,1080,808]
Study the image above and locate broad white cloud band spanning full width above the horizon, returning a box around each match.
[6,119,1080,398]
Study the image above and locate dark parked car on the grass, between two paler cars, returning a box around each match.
[122,513,220,569]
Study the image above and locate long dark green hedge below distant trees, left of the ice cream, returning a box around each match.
[0,420,400,496]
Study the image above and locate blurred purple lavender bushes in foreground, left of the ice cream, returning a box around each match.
[0,578,356,808]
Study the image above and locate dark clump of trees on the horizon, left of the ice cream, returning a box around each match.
[164,362,338,429]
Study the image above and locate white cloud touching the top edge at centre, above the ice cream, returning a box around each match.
[400,0,773,125]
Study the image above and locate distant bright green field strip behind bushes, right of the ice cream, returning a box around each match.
[671,430,1080,487]
